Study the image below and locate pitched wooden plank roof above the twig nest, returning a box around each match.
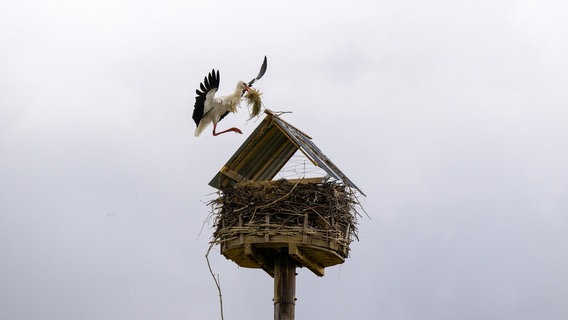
[209,110,365,195]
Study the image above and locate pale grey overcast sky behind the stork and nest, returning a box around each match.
[0,0,568,320]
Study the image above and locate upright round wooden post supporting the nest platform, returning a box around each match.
[274,248,296,320]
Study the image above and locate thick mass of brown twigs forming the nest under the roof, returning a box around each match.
[209,180,358,245]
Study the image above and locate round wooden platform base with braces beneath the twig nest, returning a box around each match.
[220,227,349,277]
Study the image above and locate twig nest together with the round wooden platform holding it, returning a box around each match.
[211,178,357,277]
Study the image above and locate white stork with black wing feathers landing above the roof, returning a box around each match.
[192,56,266,137]
